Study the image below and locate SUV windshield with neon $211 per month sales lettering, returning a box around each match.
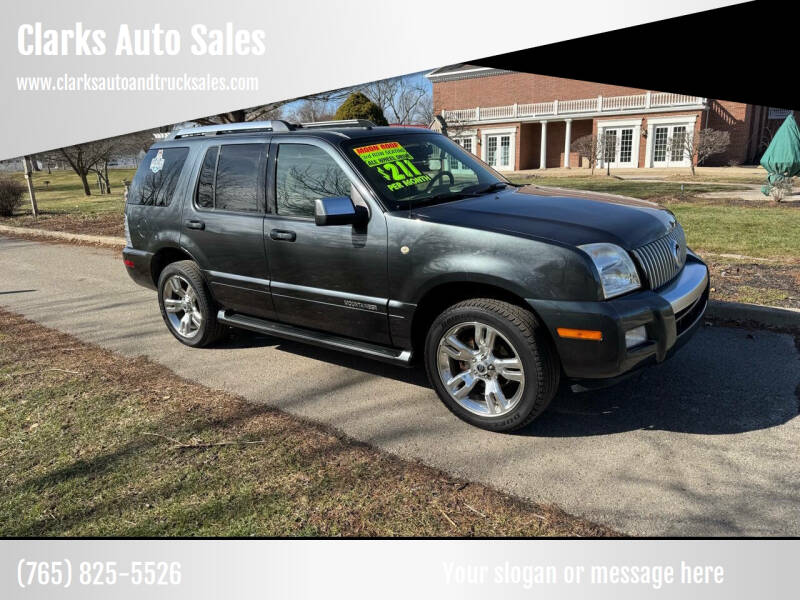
[345,133,511,210]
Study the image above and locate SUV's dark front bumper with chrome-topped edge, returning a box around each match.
[528,253,709,380]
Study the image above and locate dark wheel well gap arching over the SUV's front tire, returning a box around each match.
[411,282,531,353]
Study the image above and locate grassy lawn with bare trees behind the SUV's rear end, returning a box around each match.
[6,169,136,216]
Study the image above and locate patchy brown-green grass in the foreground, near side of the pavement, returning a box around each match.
[0,309,614,536]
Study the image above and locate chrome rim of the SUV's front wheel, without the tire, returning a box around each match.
[437,322,525,417]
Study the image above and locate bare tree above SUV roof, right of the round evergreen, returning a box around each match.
[359,77,433,125]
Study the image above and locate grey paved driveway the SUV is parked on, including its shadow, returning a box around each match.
[0,238,800,536]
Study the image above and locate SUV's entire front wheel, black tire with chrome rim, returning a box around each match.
[425,298,561,432]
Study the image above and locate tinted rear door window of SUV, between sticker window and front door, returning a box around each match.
[195,144,266,212]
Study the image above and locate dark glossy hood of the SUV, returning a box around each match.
[412,185,675,250]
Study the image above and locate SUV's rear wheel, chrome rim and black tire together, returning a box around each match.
[158,260,225,348]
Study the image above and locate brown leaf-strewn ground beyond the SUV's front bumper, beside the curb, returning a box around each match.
[706,257,800,308]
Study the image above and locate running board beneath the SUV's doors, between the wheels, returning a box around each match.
[217,310,411,367]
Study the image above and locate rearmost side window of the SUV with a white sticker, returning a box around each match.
[128,148,189,206]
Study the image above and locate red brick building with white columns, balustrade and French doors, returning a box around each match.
[427,64,787,171]
